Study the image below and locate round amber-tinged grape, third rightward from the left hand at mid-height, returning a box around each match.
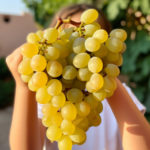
[47,60,63,78]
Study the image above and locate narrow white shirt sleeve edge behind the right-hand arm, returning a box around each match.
[122,83,146,114]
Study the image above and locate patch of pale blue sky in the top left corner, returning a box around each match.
[0,0,27,14]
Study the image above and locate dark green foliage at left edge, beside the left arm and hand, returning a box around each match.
[0,58,15,108]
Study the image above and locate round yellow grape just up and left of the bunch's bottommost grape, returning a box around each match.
[46,125,62,142]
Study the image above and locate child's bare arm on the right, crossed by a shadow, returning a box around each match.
[108,79,150,150]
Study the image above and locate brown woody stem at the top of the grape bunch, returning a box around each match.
[55,17,81,29]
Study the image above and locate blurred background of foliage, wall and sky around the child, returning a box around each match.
[0,0,150,150]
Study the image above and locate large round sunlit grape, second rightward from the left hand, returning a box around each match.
[31,55,47,72]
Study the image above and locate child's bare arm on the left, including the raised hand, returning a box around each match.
[6,48,42,150]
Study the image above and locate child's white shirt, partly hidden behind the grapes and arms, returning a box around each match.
[38,83,146,150]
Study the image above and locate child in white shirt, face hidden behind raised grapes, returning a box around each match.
[6,5,150,150]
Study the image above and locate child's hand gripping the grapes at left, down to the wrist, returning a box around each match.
[6,47,27,86]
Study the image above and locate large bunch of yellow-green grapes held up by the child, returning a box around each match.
[18,9,127,150]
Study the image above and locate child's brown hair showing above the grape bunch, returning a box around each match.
[50,4,111,32]
